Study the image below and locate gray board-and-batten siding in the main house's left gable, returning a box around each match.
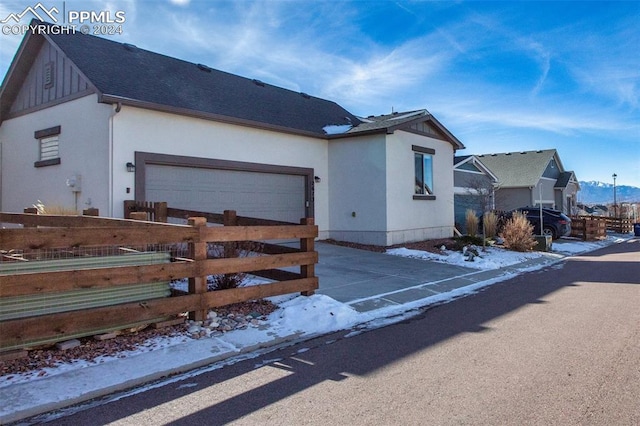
[9,42,93,117]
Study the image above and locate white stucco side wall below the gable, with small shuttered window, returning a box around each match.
[0,95,112,214]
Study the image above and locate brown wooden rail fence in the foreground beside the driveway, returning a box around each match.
[0,211,318,352]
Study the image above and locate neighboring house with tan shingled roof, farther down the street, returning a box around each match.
[476,149,580,215]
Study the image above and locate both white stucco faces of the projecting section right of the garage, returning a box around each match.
[329,131,454,245]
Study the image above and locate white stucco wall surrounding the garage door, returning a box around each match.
[113,106,329,238]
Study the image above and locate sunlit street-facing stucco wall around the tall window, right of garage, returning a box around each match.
[386,131,454,245]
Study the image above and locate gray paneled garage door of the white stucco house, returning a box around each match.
[145,164,306,223]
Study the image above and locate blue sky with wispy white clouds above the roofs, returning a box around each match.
[0,0,640,186]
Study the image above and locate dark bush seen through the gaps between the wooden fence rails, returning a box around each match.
[207,241,264,290]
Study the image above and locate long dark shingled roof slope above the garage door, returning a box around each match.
[40,23,360,137]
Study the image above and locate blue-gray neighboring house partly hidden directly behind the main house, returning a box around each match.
[453,155,498,233]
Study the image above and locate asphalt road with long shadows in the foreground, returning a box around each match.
[41,238,640,425]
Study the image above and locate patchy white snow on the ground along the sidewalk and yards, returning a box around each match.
[0,236,626,404]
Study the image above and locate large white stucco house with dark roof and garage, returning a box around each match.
[0,24,464,245]
